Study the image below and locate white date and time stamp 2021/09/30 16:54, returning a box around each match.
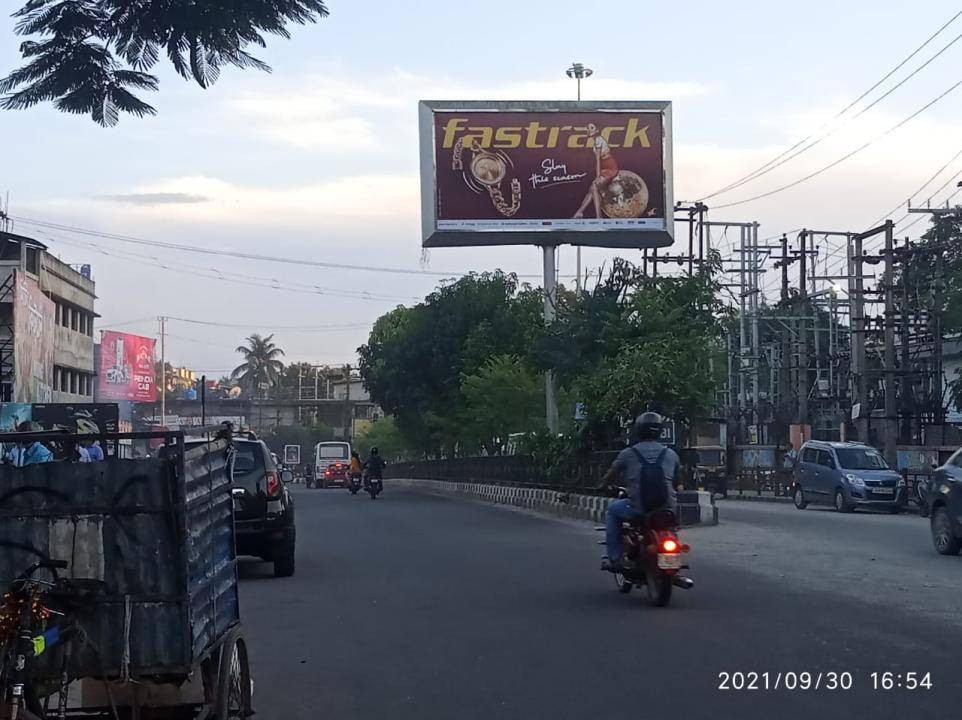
[718,670,934,691]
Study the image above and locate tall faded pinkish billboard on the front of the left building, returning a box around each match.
[13,271,56,403]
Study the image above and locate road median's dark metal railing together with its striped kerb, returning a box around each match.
[387,455,718,527]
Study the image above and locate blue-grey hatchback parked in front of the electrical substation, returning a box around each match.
[792,440,907,513]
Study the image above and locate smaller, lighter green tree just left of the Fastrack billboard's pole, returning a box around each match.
[461,355,544,455]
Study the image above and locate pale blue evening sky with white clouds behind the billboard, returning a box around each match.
[0,0,962,376]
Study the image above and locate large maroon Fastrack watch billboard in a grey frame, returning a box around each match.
[420,101,674,248]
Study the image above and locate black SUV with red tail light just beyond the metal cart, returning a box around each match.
[232,438,296,577]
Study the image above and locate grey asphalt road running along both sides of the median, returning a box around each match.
[241,487,962,720]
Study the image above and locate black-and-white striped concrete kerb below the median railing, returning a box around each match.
[388,479,718,526]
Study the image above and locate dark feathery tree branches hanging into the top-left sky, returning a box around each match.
[0,0,328,127]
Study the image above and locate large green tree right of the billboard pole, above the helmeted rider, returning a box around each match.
[535,257,729,447]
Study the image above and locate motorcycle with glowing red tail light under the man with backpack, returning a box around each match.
[597,488,695,607]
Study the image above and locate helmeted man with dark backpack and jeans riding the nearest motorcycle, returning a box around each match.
[602,412,679,571]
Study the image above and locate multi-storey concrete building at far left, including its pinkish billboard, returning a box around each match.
[0,231,98,403]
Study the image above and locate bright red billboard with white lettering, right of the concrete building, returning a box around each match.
[97,330,157,402]
